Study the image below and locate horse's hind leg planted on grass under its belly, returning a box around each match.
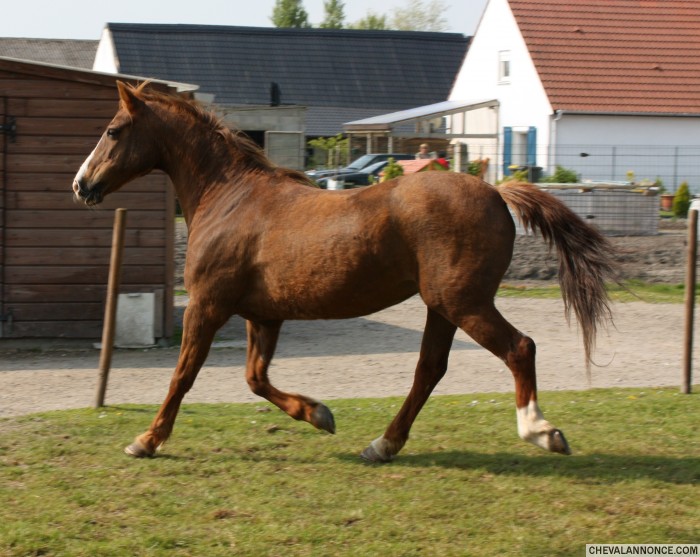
[362,309,457,462]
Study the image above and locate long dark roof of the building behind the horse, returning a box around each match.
[108,23,469,135]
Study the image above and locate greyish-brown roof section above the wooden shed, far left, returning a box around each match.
[0,38,99,70]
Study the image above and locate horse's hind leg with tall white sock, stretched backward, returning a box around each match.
[459,304,571,454]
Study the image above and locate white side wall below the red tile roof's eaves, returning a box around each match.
[549,113,700,191]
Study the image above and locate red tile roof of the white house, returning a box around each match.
[508,0,700,114]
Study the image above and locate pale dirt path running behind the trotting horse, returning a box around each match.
[0,298,700,417]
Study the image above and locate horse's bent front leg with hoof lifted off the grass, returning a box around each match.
[246,321,335,433]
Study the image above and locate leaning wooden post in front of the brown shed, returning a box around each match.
[95,209,126,408]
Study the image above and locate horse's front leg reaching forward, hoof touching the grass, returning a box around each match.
[124,301,221,457]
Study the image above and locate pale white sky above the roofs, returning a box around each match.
[0,0,487,39]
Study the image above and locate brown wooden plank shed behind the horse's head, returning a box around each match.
[0,58,186,339]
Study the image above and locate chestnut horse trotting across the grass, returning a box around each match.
[73,83,614,462]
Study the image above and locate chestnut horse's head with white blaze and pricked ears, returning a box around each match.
[73,81,158,205]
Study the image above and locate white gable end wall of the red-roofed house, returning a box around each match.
[450,0,552,175]
